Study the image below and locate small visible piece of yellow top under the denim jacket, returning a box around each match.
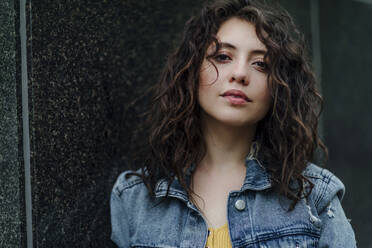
[205,223,232,248]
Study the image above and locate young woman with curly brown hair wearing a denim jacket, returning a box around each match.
[111,0,356,248]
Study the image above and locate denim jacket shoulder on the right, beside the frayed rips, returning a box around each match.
[303,163,345,212]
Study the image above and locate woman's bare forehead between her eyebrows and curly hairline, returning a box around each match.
[216,17,266,51]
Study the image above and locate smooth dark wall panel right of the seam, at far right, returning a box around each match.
[320,0,372,247]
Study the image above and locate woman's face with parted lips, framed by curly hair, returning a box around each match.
[198,17,271,127]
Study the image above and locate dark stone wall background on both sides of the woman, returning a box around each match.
[0,0,372,248]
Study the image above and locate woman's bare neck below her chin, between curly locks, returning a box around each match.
[198,113,256,173]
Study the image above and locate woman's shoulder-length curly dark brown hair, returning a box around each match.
[129,0,328,209]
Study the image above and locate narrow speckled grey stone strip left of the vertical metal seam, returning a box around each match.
[0,0,25,248]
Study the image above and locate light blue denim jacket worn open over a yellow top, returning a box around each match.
[111,157,356,248]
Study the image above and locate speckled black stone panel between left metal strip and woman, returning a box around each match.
[29,0,200,247]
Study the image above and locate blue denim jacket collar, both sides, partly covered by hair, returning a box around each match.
[155,149,271,202]
